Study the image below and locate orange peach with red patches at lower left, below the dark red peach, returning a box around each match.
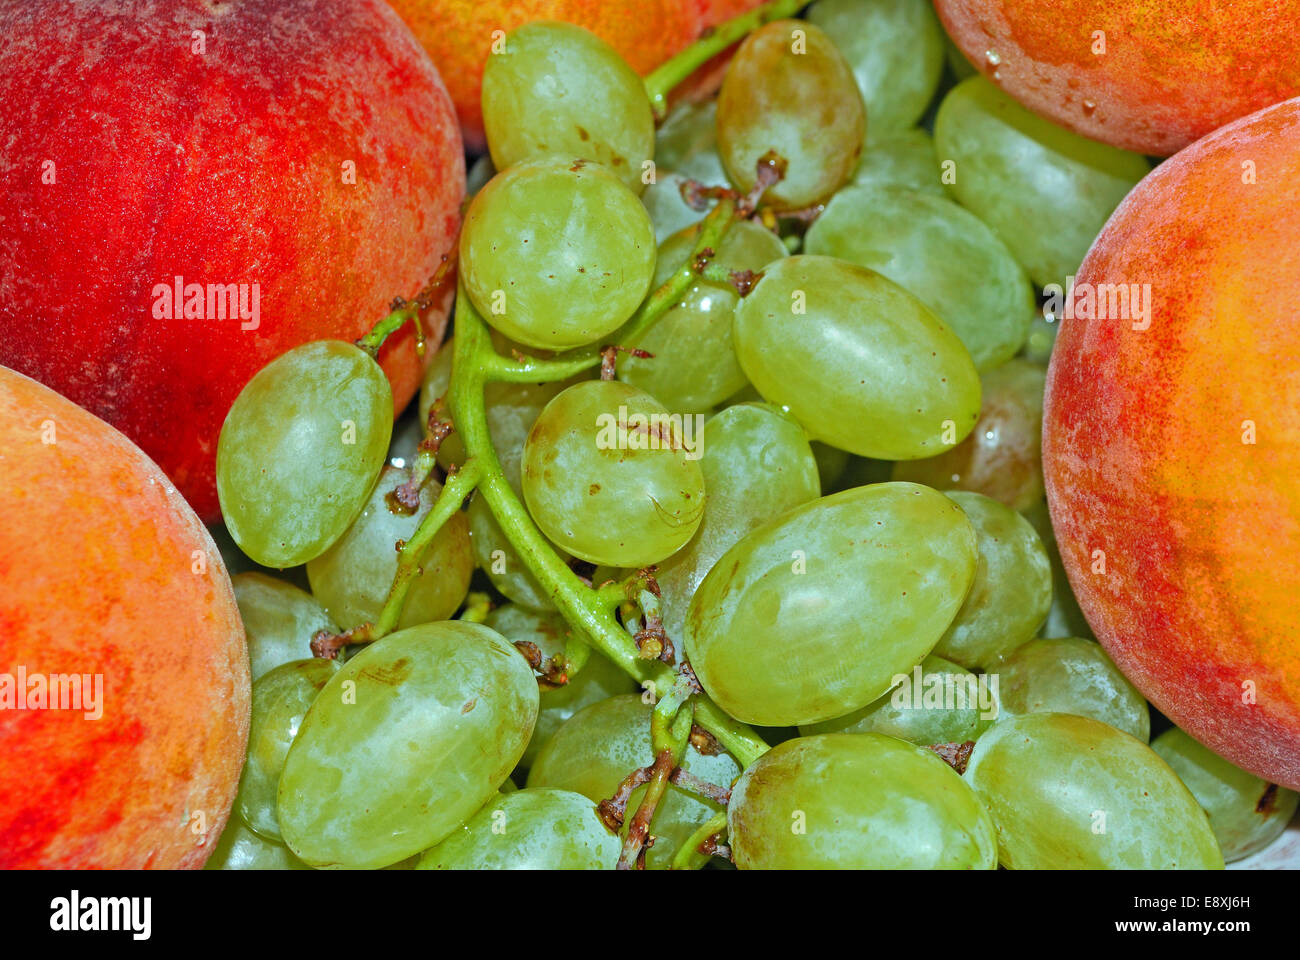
[0,367,248,869]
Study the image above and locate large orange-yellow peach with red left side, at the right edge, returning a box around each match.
[1043,98,1300,788]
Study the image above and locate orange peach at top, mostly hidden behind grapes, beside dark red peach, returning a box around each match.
[391,0,763,152]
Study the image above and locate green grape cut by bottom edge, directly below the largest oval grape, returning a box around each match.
[727,734,997,870]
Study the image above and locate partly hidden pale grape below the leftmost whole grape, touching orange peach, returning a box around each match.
[230,572,338,680]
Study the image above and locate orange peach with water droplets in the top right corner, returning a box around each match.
[935,0,1300,156]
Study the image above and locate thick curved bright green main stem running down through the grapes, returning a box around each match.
[447,286,768,767]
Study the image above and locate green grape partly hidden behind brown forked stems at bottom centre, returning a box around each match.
[528,693,740,870]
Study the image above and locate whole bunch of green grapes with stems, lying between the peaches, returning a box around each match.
[202,0,1297,869]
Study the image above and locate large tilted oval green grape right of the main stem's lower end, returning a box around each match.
[685,484,978,726]
